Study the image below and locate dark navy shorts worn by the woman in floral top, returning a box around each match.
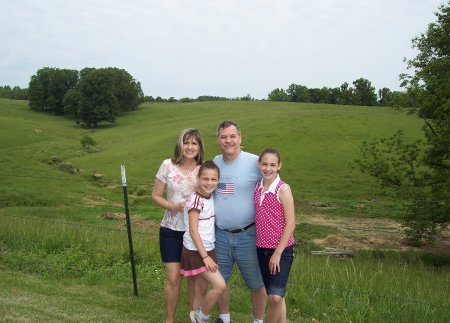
[159,227,184,262]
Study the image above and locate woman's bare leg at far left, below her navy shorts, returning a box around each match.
[165,262,181,323]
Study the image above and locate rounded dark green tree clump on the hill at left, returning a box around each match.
[28,67,144,128]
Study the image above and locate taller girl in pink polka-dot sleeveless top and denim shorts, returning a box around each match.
[254,148,295,323]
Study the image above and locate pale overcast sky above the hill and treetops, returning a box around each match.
[0,0,444,99]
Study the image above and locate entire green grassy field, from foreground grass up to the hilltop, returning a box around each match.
[0,100,450,322]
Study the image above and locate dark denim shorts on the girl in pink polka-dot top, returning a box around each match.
[257,246,294,297]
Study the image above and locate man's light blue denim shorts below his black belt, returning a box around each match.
[215,226,264,290]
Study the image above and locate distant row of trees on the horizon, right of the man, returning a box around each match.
[268,78,406,106]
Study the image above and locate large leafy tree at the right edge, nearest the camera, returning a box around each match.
[359,2,450,242]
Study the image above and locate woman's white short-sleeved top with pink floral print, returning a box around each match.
[156,159,200,231]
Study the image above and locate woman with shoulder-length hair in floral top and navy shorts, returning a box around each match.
[152,128,206,323]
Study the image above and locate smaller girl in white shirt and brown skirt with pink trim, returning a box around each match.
[180,161,226,323]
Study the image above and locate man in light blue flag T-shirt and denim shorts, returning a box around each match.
[214,121,266,323]
